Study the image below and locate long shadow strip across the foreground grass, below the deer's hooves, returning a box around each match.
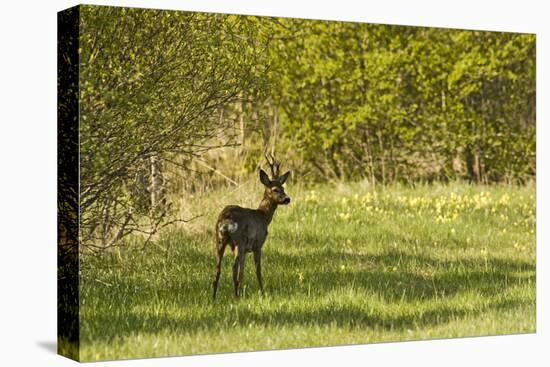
[84,299,536,343]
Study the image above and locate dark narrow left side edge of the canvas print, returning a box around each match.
[57,5,80,361]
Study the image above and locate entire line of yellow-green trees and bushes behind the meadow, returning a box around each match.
[75,6,536,247]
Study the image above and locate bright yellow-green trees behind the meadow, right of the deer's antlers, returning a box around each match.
[270,20,535,182]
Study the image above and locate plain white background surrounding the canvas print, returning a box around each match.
[0,0,550,367]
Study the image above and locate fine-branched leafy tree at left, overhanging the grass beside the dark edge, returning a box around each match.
[79,6,270,246]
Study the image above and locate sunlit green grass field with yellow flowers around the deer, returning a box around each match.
[75,183,535,361]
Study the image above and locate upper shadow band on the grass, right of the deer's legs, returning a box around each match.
[271,250,535,302]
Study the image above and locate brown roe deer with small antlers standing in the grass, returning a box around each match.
[212,156,290,299]
